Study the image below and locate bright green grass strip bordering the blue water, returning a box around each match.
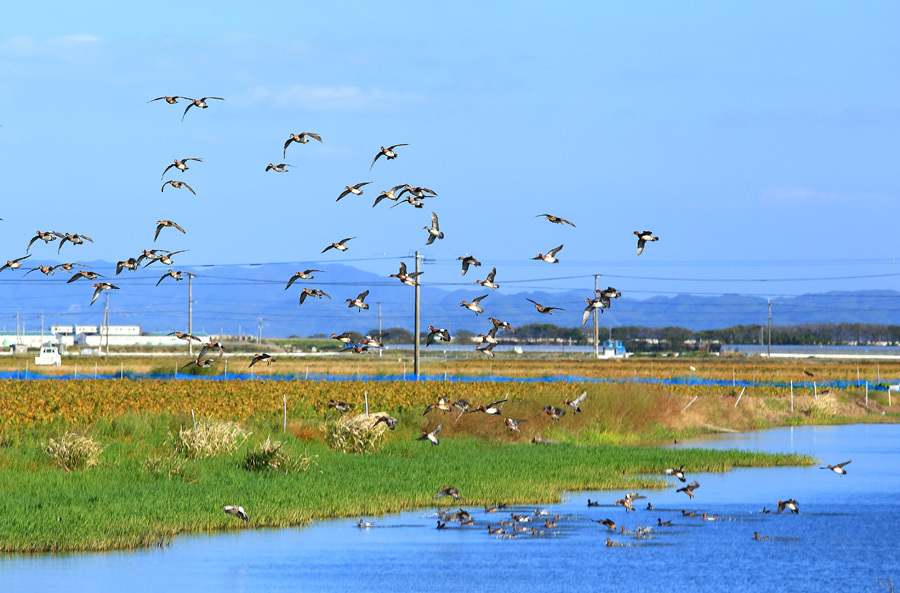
[0,412,815,552]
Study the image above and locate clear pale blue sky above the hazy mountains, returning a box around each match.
[0,1,900,332]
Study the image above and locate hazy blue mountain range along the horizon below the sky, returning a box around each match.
[0,260,900,337]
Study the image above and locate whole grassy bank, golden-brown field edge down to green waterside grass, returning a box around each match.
[0,364,897,551]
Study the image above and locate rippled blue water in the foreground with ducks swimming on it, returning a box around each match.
[0,425,900,593]
